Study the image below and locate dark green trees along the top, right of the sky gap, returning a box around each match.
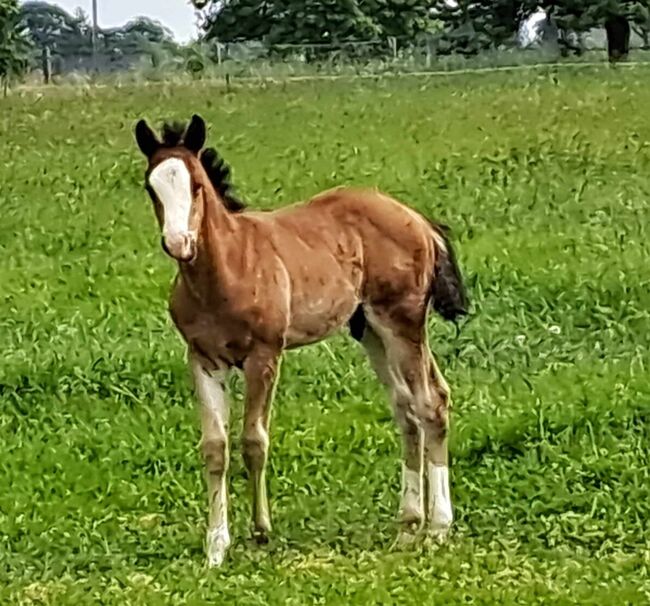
[192,0,650,60]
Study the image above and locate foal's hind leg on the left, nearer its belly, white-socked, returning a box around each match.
[361,326,424,527]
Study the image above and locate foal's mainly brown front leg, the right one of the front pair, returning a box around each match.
[242,348,280,543]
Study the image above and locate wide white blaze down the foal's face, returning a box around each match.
[149,158,192,238]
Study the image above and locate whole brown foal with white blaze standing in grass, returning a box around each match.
[135,115,467,566]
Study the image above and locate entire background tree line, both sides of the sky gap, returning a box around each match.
[0,0,650,86]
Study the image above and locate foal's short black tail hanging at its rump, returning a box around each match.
[431,222,469,322]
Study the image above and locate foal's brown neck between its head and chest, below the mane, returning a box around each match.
[179,187,240,301]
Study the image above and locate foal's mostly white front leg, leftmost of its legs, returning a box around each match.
[190,356,230,566]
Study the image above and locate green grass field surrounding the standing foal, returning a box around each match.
[0,68,650,606]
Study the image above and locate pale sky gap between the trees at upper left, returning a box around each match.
[28,0,196,42]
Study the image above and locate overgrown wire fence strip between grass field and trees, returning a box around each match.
[22,30,650,88]
